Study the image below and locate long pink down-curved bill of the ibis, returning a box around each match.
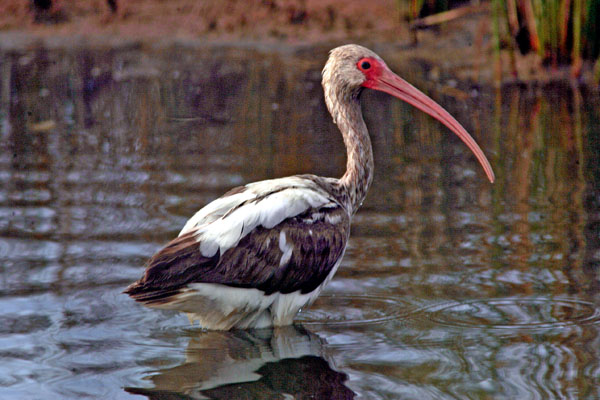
[365,68,495,183]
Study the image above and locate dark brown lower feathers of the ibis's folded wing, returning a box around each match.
[125,203,350,303]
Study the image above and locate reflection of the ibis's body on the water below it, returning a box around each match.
[125,325,355,399]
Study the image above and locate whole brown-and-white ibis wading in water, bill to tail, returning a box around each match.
[125,44,494,330]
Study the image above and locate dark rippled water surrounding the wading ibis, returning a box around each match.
[0,47,600,399]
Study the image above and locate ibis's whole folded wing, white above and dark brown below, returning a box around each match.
[125,178,350,306]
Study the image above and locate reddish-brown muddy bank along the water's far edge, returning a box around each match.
[0,0,598,89]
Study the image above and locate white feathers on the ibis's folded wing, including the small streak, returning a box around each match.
[179,177,337,258]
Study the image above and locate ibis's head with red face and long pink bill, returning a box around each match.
[322,44,495,182]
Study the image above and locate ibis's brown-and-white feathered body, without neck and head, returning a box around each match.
[130,175,350,329]
